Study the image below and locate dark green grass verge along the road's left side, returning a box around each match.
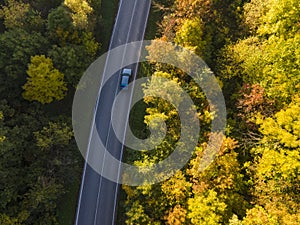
[56,0,119,225]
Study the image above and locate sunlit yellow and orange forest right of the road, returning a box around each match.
[120,0,300,225]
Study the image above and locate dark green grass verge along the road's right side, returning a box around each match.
[117,2,162,224]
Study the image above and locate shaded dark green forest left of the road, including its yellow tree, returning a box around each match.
[0,0,107,225]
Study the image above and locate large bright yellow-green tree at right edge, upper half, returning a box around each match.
[235,34,300,103]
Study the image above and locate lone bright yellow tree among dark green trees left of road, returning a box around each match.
[23,55,67,104]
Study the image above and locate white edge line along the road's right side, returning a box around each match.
[112,0,151,225]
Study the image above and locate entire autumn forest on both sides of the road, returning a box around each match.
[0,0,300,225]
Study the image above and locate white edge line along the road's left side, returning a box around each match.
[75,0,123,225]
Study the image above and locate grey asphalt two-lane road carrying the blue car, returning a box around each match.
[75,0,151,225]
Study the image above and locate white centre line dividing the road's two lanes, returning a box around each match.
[94,0,139,225]
